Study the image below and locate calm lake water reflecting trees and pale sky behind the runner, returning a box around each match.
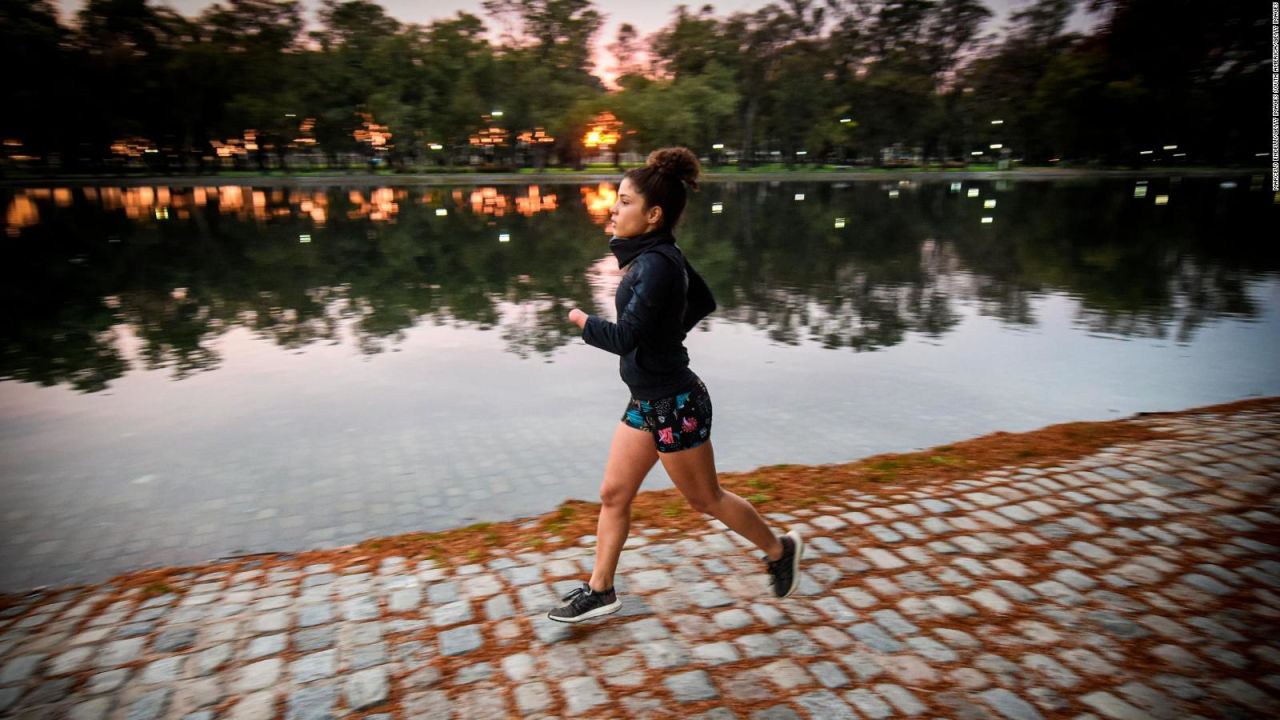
[0,173,1280,589]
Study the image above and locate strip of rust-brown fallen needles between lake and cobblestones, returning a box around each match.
[0,396,1280,599]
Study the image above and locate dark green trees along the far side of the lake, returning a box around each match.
[0,0,1270,172]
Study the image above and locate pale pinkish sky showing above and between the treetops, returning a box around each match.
[54,0,1092,77]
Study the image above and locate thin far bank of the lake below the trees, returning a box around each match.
[0,168,1266,187]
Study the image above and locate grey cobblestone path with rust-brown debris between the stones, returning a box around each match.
[0,406,1280,720]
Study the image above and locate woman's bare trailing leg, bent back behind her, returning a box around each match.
[660,441,782,560]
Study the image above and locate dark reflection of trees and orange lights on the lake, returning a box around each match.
[0,179,1280,392]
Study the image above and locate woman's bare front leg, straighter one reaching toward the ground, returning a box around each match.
[591,423,658,591]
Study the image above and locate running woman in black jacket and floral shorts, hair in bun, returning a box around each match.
[548,147,804,623]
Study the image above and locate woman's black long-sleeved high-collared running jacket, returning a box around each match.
[582,229,716,400]
